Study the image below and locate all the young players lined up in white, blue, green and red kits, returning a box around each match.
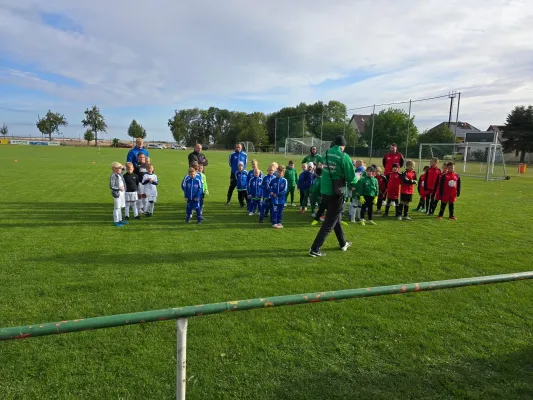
[110,153,461,229]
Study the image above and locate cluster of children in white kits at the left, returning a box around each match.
[109,153,159,227]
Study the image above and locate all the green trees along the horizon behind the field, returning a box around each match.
[0,100,533,162]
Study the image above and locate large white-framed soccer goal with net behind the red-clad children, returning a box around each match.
[418,142,509,181]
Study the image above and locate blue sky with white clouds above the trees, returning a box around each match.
[0,0,533,140]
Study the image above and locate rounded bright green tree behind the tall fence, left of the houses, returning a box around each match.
[363,108,418,148]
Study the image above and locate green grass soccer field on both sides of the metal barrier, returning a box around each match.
[0,146,533,399]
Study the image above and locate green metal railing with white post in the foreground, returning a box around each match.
[0,271,533,400]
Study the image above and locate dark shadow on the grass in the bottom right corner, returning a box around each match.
[273,348,533,399]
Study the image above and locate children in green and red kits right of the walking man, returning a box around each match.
[347,158,461,225]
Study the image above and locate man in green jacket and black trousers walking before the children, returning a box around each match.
[309,136,356,257]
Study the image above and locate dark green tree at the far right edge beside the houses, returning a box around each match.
[502,105,533,163]
